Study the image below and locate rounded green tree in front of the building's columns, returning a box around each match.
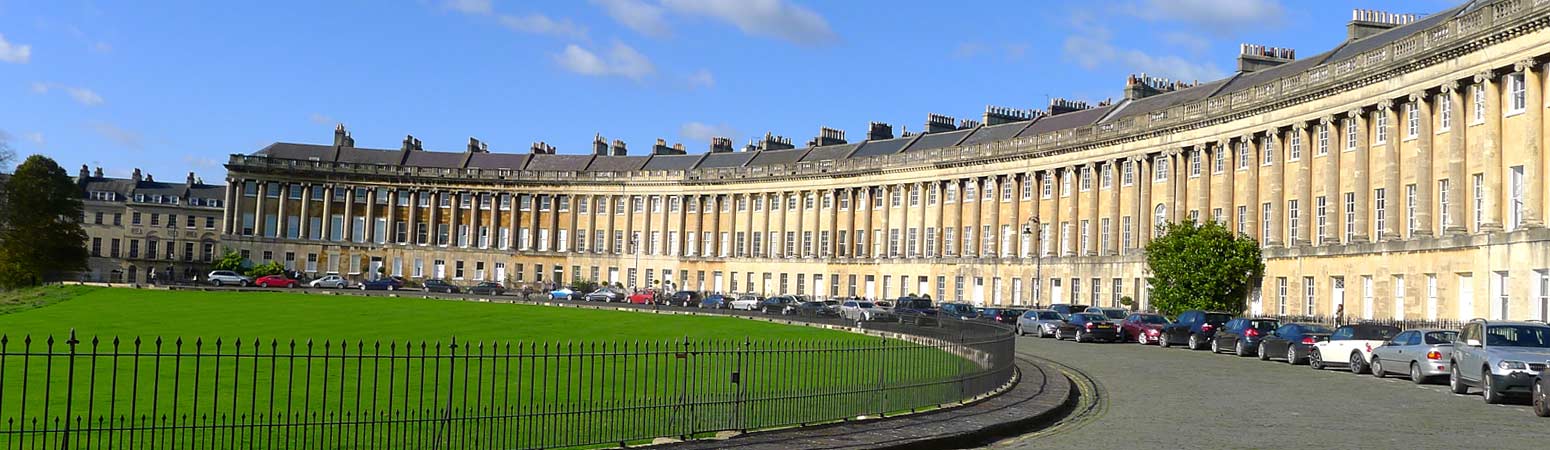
[1145,220,1265,315]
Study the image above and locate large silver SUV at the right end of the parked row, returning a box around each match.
[1448,318,1550,403]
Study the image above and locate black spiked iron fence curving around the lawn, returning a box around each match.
[0,307,1015,448]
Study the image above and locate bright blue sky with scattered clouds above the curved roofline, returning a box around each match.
[0,0,1455,180]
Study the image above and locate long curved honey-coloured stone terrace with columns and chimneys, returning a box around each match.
[223,0,1550,318]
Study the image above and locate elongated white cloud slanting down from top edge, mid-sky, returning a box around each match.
[662,0,839,45]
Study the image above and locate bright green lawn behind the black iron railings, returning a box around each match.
[0,287,972,448]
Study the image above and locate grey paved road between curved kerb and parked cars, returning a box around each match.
[990,337,1550,448]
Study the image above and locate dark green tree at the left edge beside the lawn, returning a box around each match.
[0,155,87,289]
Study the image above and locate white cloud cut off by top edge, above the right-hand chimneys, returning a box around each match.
[1119,0,1287,34]
